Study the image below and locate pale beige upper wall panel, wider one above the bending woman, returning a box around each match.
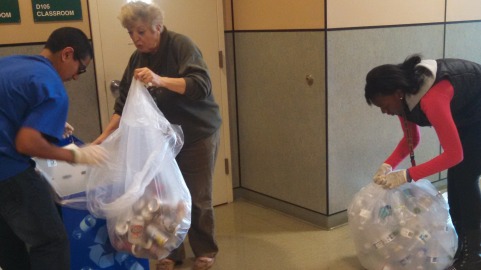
[327,0,444,28]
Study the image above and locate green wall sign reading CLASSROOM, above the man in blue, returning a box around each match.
[31,0,82,22]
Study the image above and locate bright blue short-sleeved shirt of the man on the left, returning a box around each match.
[0,55,69,181]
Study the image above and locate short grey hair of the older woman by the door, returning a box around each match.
[117,1,164,29]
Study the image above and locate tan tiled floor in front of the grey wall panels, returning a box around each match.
[151,200,363,270]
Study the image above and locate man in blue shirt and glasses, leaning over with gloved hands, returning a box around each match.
[0,27,106,270]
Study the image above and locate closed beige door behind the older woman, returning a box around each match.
[88,0,233,205]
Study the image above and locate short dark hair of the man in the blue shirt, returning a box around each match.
[45,27,94,60]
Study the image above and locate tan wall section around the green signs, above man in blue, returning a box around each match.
[0,0,90,45]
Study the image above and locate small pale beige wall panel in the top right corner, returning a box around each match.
[446,0,481,22]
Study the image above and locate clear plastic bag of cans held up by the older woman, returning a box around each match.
[87,79,191,259]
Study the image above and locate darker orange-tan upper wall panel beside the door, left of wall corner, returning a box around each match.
[233,0,324,30]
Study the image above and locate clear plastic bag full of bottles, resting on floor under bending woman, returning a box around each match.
[348,179,457,270]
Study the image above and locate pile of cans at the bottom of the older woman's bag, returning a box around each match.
[109,188,190,259]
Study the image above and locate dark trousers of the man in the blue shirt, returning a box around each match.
[0,168,70,270]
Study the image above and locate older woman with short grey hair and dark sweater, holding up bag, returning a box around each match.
[94,1,221,270]
